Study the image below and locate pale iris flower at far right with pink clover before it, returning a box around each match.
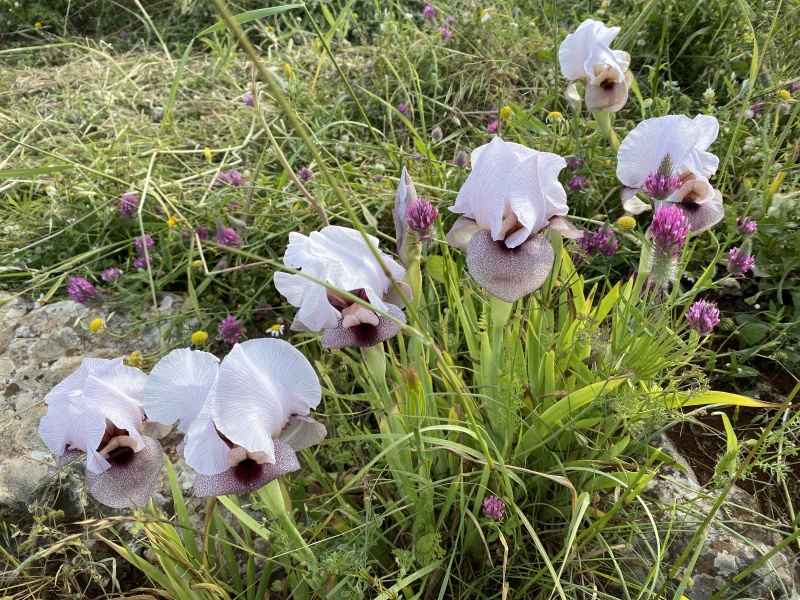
[617,115,725,234]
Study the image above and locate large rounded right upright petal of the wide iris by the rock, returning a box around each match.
[213,339,322,462]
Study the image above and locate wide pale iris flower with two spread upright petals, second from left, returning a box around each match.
[144,339,327,497]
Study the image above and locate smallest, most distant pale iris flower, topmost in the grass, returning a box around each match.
[558,19,633,112]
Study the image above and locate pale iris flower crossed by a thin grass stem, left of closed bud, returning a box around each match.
[275,226,411,348]
